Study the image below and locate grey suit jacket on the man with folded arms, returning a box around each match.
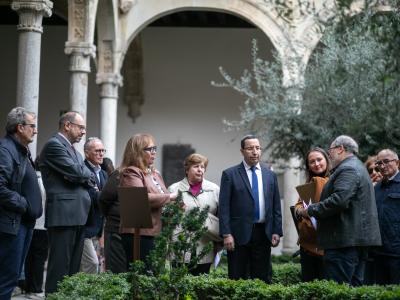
[39,134,95,227]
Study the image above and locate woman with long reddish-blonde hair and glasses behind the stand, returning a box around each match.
[120,133,177,263]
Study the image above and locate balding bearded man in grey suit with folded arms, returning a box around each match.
[39,112,95,294]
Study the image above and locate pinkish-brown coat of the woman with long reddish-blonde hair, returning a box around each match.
[119,166,169,236]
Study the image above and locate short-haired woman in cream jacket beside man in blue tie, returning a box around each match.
[168,153,220,275]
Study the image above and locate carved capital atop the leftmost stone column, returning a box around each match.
[11,0,53,33]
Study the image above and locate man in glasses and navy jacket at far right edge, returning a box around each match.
[375,149,400,285]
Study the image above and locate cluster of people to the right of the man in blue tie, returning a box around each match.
[295,135,400,286]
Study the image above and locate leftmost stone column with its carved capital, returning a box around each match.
[11,0,53,158]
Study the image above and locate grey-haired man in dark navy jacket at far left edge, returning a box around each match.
[0,107,42,299]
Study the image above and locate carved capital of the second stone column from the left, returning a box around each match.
[64,42,96,73]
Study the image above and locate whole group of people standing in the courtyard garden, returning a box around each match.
[0,107,400,299]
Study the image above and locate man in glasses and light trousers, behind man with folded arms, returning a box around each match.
[81,137,107,274]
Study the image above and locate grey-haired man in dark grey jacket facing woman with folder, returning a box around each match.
[298,135,381,286]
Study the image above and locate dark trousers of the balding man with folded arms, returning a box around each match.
[46,226,85,294]
